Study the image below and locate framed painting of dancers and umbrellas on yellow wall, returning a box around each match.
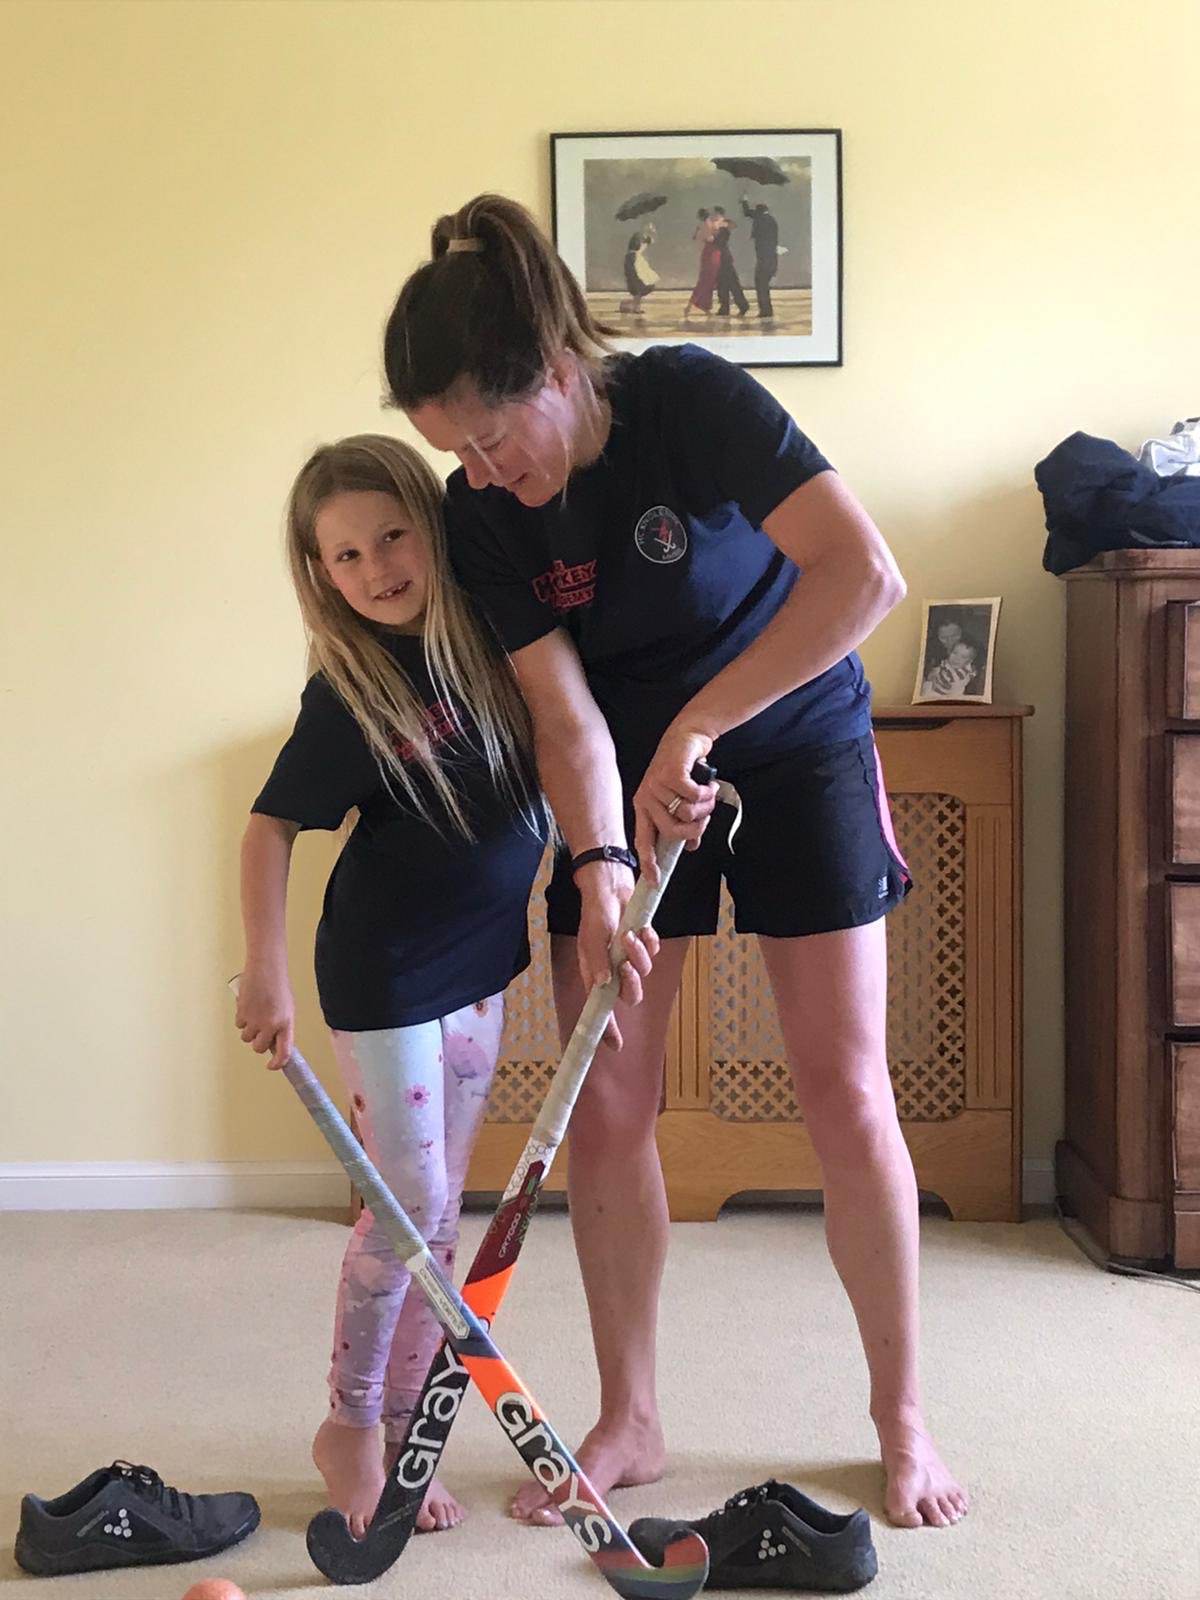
[550,128,842,366]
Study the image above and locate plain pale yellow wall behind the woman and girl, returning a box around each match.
[0,0,1200,1162]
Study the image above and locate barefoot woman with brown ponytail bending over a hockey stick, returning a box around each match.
[384,195,966,1526]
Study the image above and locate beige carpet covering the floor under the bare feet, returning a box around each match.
[0,1210,1200,1600]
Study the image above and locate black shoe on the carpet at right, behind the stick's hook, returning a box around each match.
[629,1478,878,1594]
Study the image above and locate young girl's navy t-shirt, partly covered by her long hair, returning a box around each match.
[253,635,546,1032]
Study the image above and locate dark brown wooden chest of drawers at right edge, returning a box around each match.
[1058,550,1200,1267]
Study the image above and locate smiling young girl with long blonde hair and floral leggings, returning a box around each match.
[237,435,546,1536]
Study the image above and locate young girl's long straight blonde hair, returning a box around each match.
[286,434,539,838]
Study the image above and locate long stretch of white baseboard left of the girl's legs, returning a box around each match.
[0,1162,350,1211]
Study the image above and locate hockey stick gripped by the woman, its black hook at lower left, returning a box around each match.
[307,762,741,1584]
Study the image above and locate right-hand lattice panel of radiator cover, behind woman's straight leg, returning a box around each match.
[709,794,966,1122]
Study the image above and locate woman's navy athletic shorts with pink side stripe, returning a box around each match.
[546,734,912,939]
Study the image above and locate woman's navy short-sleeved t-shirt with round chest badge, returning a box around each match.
[446,344,870,782]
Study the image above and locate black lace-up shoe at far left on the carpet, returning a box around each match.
[16,1461,261,1578]
